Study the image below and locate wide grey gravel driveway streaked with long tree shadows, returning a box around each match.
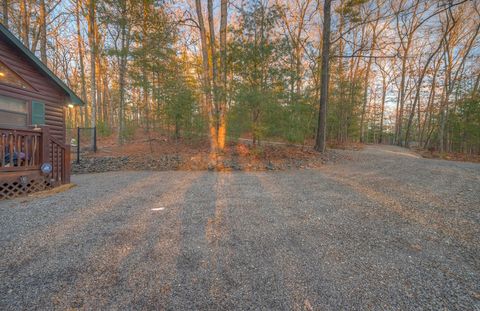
[0,146,480,310]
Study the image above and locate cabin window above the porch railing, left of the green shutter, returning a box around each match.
[0,96,28,127]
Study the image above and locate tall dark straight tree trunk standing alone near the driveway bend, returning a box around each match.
[315,0,332,152]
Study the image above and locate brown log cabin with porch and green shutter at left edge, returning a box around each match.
[0,23,84,200]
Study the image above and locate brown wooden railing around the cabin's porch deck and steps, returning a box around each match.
[0,127,70,184]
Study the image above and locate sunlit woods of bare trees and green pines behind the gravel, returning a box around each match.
[1,0,480,154]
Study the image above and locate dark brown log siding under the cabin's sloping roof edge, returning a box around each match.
[0,36,66,142]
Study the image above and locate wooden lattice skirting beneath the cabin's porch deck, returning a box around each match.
[0,175,54,200]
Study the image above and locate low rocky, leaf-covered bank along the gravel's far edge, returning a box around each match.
[72,144,345,174]
